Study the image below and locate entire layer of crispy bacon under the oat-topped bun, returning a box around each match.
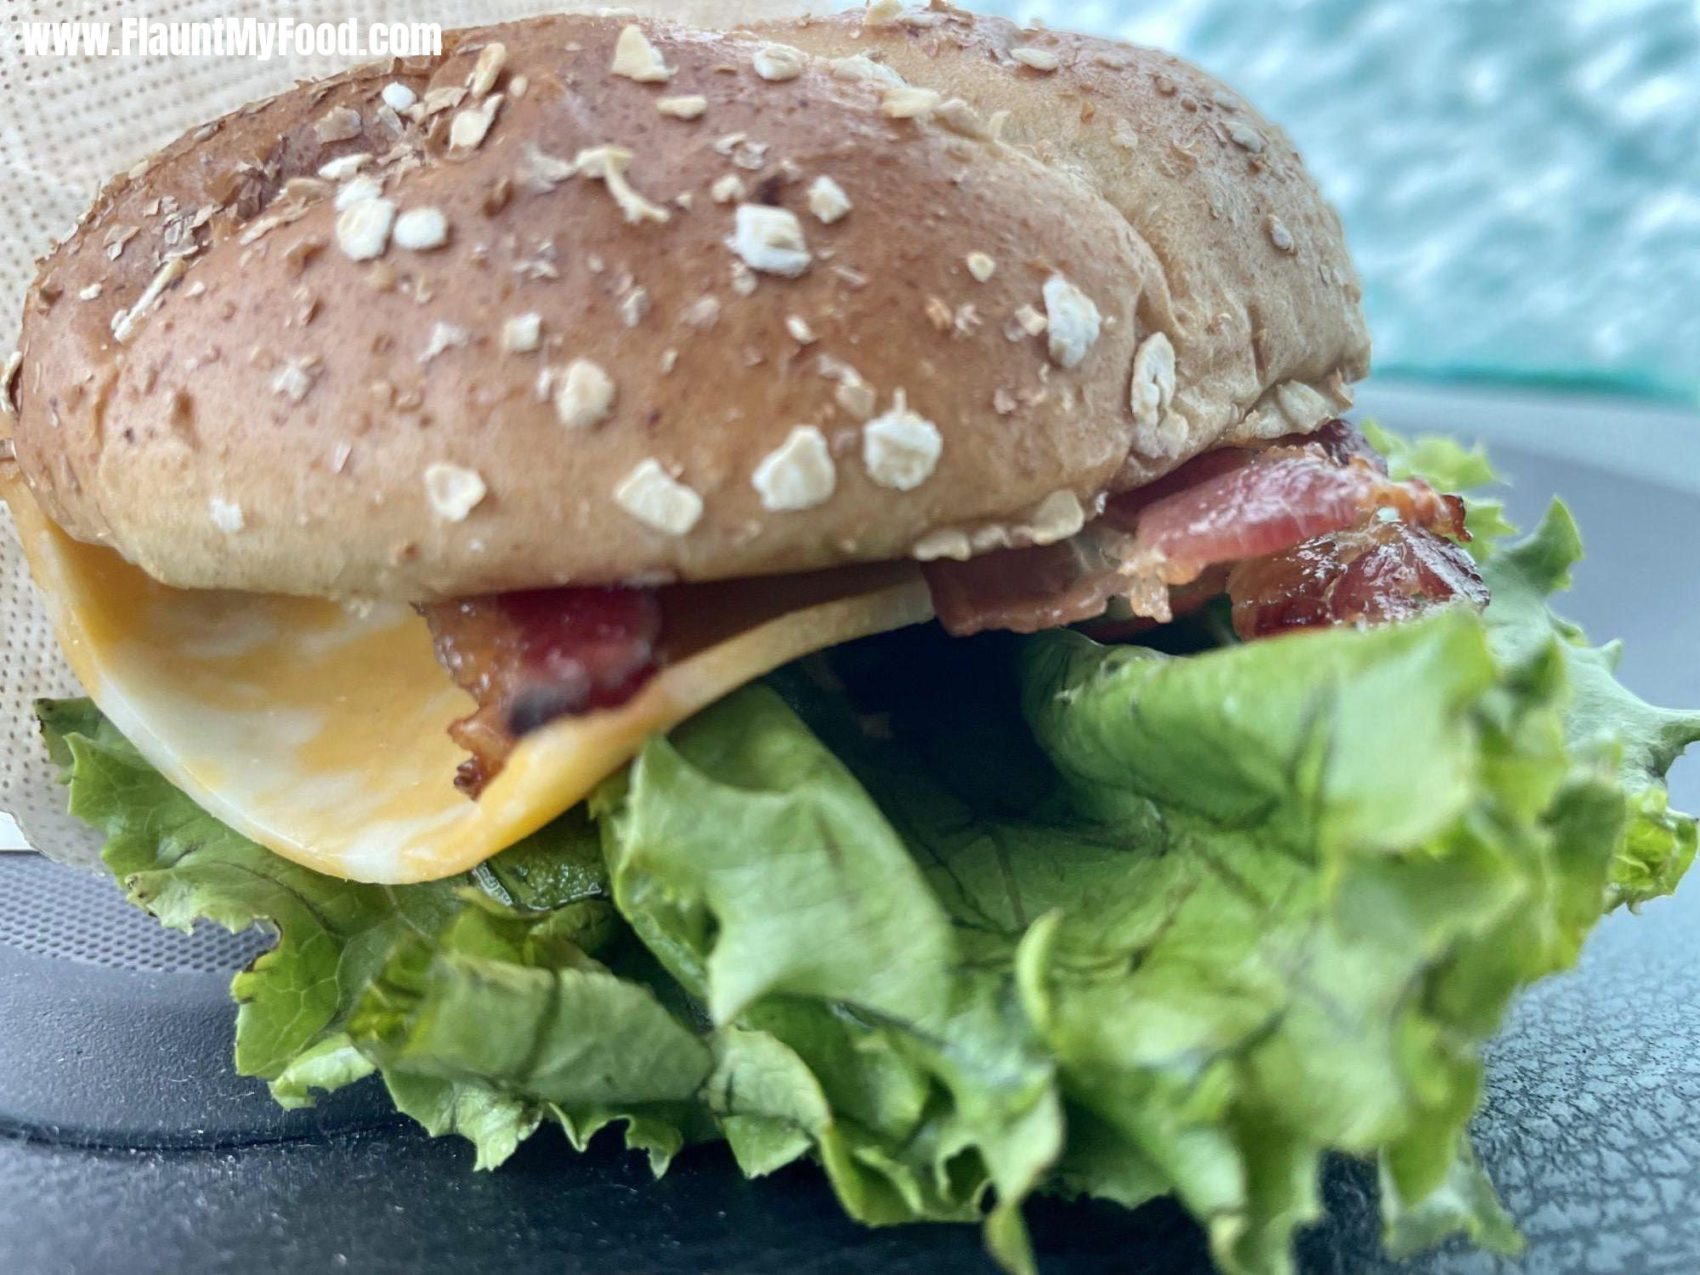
[423,422,1488,796]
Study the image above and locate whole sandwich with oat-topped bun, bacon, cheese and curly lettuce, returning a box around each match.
[0,0,1700,1272]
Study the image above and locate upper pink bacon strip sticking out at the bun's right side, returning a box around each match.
[927,422,1469,636]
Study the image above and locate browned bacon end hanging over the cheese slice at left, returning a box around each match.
[423,588,661,796]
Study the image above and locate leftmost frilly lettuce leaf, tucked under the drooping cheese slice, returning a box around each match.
[37,700,663,1166]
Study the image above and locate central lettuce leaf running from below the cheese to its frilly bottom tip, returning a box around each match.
[595,687,1063,1268]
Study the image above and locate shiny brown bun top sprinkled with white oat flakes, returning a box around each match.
[15,5,1369,600]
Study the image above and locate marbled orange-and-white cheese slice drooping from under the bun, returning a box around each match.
[0,478,932,884]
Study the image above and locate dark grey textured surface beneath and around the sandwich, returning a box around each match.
[0,396,1700,1275]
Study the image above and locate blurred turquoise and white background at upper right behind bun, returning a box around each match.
[976,0,1700,403]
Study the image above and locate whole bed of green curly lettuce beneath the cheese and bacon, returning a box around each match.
[41,496,1700,1273]
